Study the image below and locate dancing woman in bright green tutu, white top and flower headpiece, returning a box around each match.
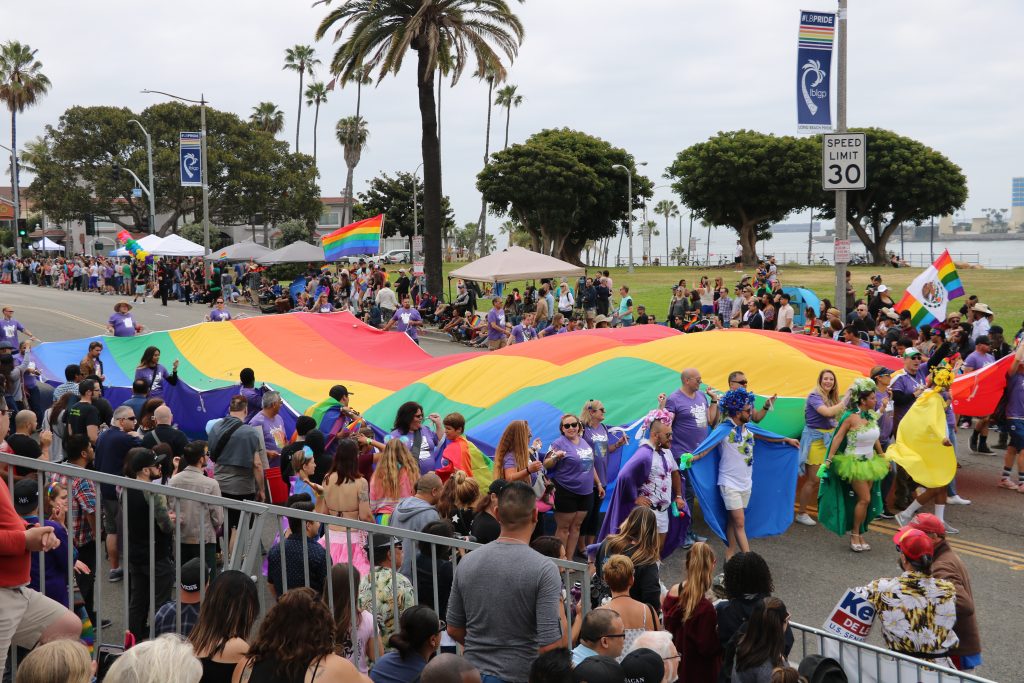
[818,377,889,553]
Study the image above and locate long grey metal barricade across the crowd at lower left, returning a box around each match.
[0,453,590,668]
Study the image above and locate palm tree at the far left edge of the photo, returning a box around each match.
[0,40,50,255]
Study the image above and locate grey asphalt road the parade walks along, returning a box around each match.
[0,285,1024,681]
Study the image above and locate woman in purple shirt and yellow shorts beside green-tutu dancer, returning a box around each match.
[794,370,850,526]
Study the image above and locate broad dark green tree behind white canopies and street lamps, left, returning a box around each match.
[32,102,323,234]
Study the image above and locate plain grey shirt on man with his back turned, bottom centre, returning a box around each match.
[445,541,562,683]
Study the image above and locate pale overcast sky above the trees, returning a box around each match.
[6,0,1024,232]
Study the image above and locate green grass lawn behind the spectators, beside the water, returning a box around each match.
[438,263,1024,325]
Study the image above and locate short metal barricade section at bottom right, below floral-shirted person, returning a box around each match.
[790,622,995,683]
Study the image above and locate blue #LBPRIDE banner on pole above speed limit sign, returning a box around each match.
[797,10,836,132]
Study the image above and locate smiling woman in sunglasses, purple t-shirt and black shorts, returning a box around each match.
[544,415,604,565]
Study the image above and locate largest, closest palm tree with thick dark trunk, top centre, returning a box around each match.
[316,0,523,293]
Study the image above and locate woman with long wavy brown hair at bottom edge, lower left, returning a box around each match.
[231,588,360,683]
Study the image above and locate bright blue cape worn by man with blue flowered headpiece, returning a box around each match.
[687,420,799,540]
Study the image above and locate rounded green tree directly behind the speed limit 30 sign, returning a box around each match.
[815,128,968,265]
